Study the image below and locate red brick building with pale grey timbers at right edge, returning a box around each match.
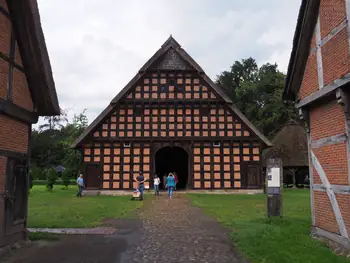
[284,0,350,250]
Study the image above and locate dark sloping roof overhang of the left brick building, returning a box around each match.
[7,0,60,116]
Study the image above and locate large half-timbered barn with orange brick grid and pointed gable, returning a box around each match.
[73,36,271,193]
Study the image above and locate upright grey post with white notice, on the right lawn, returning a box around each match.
[266,159,283,217]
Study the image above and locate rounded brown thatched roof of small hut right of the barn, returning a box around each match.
[262,122,309,167]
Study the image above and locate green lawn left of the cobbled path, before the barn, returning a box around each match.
[28,186,142,228]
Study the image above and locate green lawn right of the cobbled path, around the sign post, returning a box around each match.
[189,190,350,263]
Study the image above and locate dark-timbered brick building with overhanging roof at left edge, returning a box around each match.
[0,0,59,247]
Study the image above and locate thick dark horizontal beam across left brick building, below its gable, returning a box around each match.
[0,98,38,123]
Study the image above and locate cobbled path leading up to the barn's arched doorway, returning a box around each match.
[122,195,246,263]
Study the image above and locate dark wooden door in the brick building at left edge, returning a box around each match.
[4,158,28,236]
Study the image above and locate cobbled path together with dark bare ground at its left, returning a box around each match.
[0,194,245,263]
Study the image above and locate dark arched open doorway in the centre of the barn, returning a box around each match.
[155,146,188,189]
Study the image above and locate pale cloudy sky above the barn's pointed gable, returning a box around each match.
[38,0,301,127]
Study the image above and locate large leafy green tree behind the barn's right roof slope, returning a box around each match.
[217,58,298,137]
